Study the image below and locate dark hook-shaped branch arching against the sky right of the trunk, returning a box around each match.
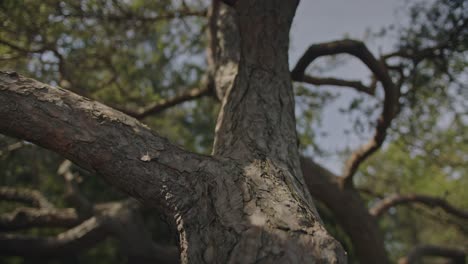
[291,39,399,186]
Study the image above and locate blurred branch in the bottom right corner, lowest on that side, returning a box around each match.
[398,245,466,264]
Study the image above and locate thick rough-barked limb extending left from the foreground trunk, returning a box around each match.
[0,72,214,216]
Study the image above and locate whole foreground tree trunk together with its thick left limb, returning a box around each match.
[0,0,346,263]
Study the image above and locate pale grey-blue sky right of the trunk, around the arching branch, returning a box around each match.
[289,0,405,173]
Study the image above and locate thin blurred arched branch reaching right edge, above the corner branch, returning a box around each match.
[369,194,468,219]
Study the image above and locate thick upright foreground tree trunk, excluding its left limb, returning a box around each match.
[180,0,345,263]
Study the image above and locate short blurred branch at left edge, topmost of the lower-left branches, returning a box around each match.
[0,186,54,209]
